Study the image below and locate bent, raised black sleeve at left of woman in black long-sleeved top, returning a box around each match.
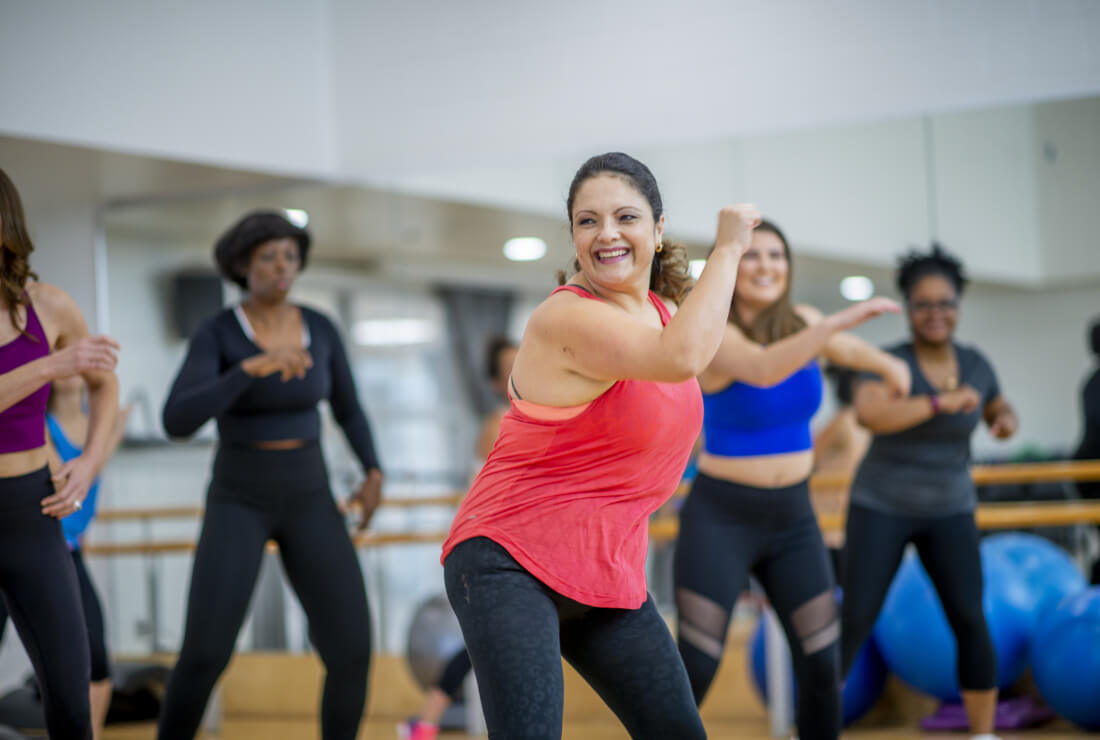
[162,322,253,437]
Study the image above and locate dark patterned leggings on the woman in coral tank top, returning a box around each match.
[443,538,706,740]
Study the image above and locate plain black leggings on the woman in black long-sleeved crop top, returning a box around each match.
[157,443,371,740]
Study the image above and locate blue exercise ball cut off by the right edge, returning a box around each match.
[1031,586,1100,730]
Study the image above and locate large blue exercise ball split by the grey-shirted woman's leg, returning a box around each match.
[873,552,1033,700]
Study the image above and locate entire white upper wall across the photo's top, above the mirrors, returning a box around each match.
[0,0,1100,181]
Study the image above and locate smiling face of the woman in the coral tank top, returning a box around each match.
[571,174,664,290]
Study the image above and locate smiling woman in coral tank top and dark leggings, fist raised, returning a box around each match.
[443,153,759,739]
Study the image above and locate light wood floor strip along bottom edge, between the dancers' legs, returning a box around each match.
[103,719,1097,740]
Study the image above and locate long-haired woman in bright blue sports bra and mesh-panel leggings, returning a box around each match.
[674,221,910,740]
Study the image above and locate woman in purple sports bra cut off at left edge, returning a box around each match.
[0,169,119,740]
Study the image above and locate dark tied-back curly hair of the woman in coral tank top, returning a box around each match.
[558,152,694,306]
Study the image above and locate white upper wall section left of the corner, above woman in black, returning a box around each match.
[0,0,337,174]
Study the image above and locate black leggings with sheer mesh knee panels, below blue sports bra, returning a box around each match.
[673,474,840,740]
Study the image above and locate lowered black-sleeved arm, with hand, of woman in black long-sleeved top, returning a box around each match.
[325,319,382,532]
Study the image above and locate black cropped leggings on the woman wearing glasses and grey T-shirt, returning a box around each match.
[840,504,997,691]
